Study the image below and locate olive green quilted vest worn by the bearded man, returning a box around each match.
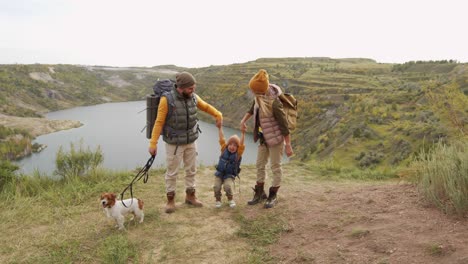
[163,88,200,145]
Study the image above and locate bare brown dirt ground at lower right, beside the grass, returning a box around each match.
[270,167,468,264]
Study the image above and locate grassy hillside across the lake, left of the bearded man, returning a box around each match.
[0,64,190,116]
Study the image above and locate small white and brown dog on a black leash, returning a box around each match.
[101,193,145,230]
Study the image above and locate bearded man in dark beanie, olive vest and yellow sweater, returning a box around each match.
[148,72,223,213]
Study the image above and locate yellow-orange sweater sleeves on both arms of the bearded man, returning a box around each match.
[150,94,223,148]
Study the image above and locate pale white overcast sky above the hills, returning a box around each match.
[0,0,468,67]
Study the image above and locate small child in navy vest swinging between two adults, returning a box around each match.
[213,127,245,208]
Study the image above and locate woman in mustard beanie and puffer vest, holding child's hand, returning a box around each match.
[240,69,293,208]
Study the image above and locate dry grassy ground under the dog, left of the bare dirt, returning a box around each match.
[0,167,286,263]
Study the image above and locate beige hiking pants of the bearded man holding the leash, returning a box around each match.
[165,142,197,193]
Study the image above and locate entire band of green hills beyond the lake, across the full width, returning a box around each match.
[0,58,468,169]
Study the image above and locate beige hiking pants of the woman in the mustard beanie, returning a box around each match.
[256,143,284,187]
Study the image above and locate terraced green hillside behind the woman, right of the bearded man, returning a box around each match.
[192,58,468,171]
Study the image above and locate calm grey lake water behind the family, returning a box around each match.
[17,101,257,175]
